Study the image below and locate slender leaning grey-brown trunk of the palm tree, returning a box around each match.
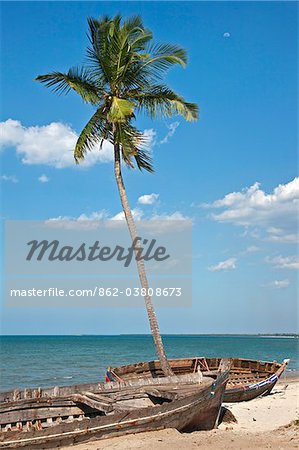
[114,144,172,376]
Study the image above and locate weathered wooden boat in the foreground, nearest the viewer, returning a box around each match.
[0,362,229,450]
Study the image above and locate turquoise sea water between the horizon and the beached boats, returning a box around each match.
[0,335,299,391]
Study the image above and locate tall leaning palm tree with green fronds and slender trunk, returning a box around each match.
[36,15,198,375]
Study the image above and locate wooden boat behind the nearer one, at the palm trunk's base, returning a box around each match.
[106,357,289,402]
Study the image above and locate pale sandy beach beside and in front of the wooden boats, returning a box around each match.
[61,378,299,450]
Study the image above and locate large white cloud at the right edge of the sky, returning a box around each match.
[202,177,299,242]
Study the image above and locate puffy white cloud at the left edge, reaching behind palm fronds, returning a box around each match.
[0,119,155,169]
